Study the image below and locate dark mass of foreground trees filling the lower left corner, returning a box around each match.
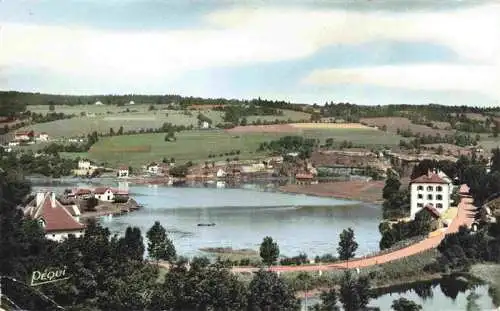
[0,171,299,311]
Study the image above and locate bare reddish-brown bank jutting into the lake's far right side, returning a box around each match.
[278,180,384,204]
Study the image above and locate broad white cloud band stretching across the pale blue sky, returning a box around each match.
[0,5,500,94]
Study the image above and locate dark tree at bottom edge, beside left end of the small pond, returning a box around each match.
[340,270,370,311]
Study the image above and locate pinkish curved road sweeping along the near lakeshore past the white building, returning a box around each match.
[232,185,474,273]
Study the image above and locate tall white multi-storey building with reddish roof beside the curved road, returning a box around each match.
[410,170,453,220]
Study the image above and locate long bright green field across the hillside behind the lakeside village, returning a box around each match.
[81,129,401,167]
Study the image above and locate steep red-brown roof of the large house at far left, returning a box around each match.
[25,193,85,232]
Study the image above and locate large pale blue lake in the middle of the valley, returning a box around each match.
[34,184,380,257]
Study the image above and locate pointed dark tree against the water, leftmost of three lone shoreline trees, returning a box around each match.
[146,221,176,261]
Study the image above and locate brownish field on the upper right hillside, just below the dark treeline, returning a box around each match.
[360,117,454,135]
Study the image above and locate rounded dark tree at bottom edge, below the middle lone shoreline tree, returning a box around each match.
[248,270,300,311]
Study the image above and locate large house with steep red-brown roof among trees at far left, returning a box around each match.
[23,191,85,242]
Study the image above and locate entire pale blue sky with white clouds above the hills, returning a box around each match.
[0,0,500,106]
